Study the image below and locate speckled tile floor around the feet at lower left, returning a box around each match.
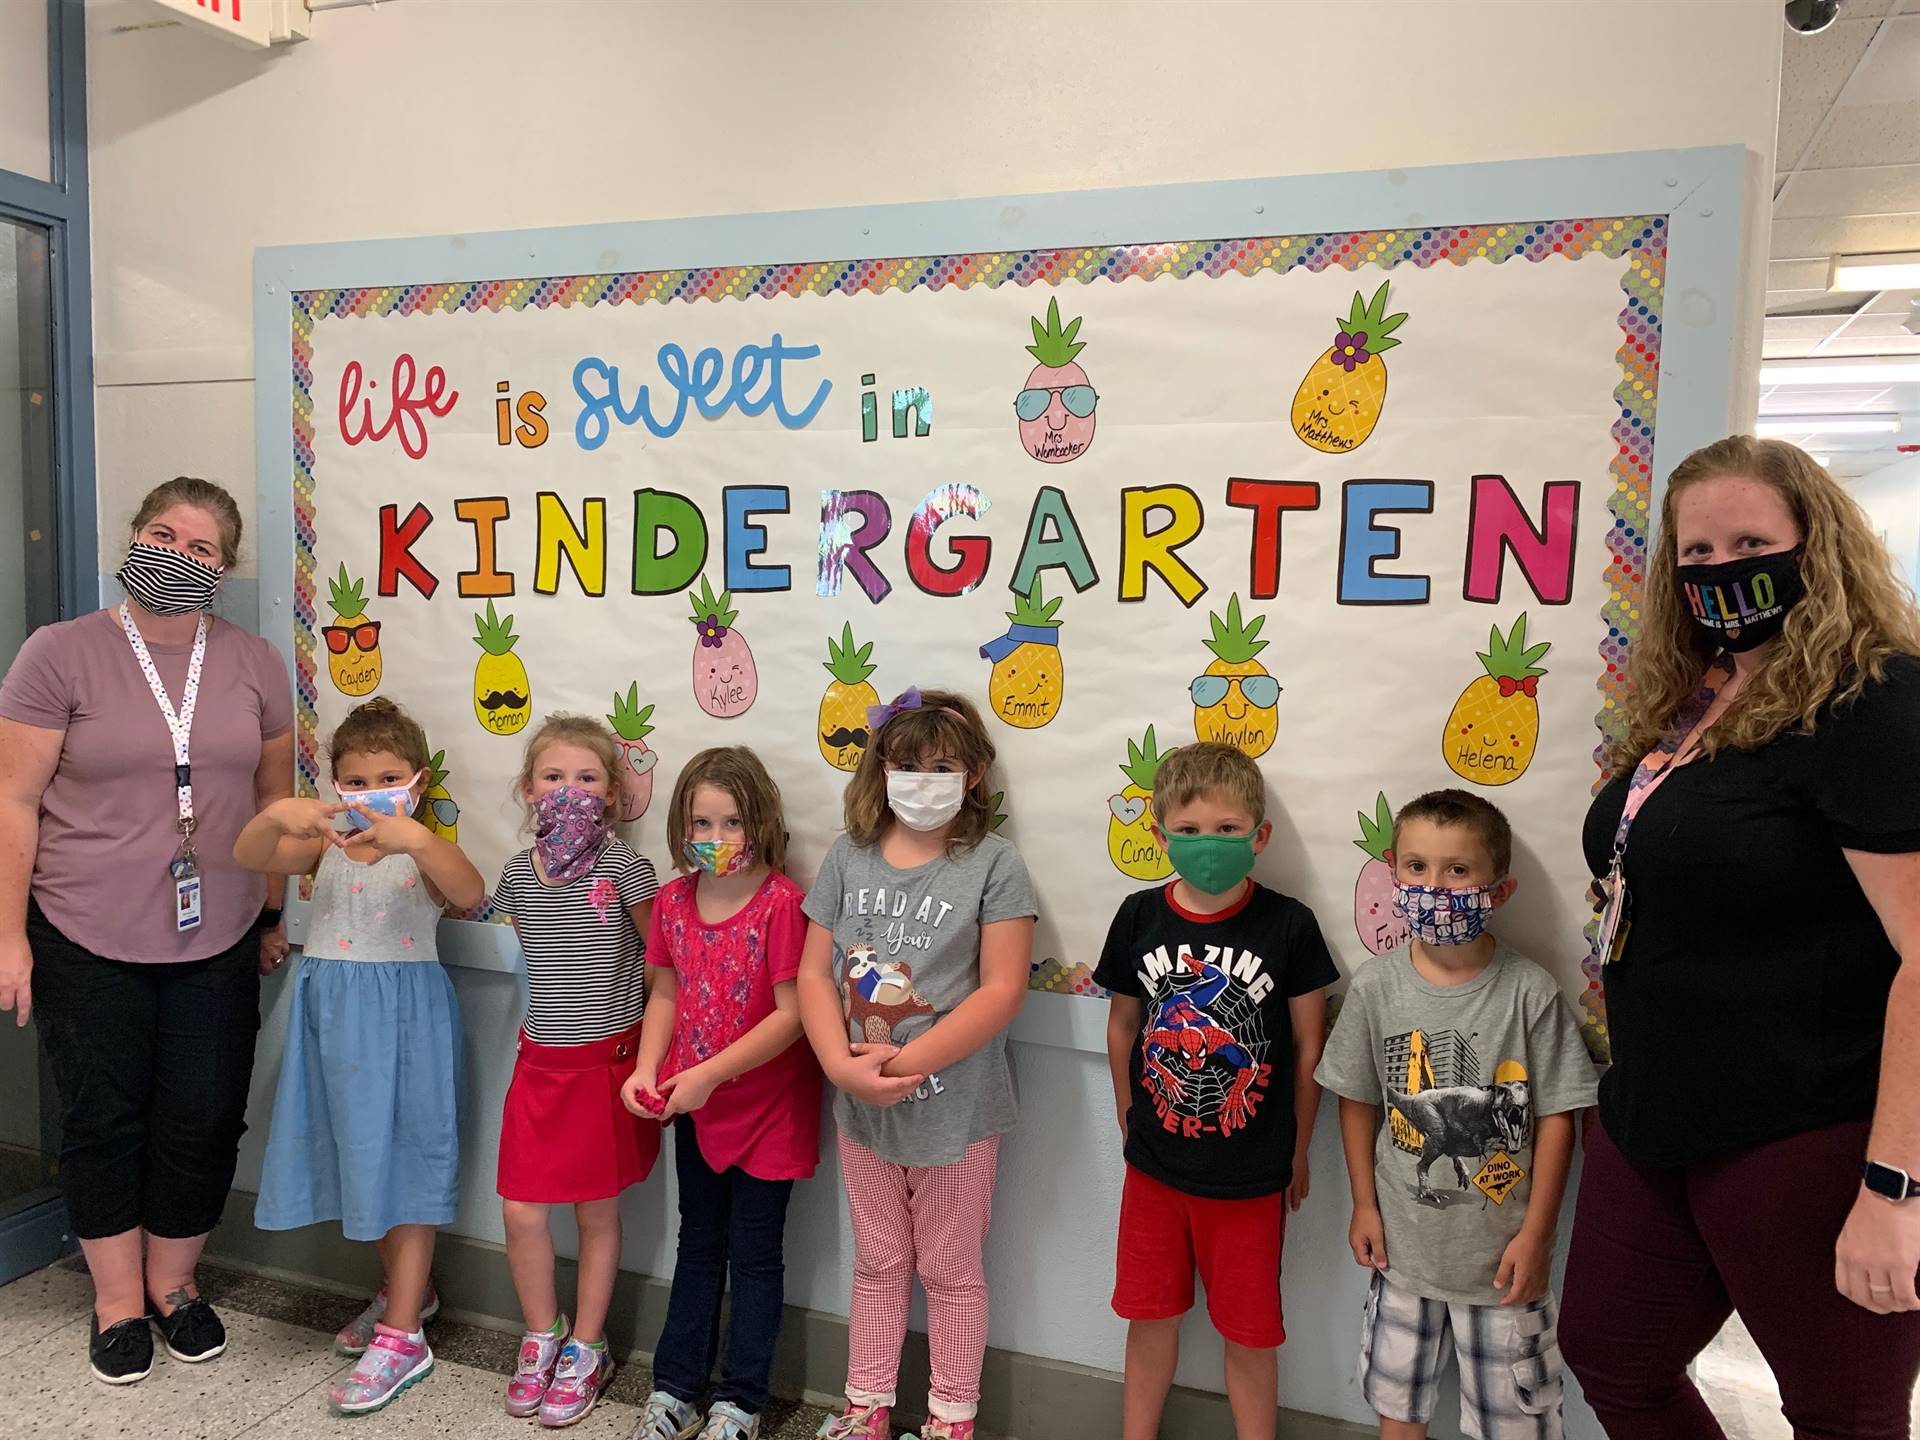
[0,1261,822,1440]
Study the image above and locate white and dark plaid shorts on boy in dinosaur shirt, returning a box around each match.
[1359,1275,1561,1440]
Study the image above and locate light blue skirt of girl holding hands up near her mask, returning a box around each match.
[253,956,461,1240]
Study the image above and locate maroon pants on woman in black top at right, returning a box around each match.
[1561,1119,1920,1440]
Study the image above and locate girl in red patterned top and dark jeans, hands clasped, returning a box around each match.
[622,747,822,1440]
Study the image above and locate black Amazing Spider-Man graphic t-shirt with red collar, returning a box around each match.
[1094,883,1340,1200]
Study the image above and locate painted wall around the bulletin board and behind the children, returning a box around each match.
[88,0,1780,1436]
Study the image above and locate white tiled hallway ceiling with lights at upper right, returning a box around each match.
[1761,0,1920,476]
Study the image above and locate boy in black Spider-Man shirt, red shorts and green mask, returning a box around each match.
[1094,743,1340,1440]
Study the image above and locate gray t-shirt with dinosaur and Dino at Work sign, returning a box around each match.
[1313,945,1596,1306]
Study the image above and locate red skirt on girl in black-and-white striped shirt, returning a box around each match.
[497,1025,660,1206]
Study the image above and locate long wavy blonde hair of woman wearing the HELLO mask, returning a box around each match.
[1605,436,1920,776]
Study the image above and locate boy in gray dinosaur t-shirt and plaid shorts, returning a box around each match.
[1315,791,1596,1440]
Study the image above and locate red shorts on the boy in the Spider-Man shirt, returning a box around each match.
[1114,1165,1286,1350]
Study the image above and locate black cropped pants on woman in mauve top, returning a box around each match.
[27,906,259,1240]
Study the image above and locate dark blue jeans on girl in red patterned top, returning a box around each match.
[653,1116,793,1415]
